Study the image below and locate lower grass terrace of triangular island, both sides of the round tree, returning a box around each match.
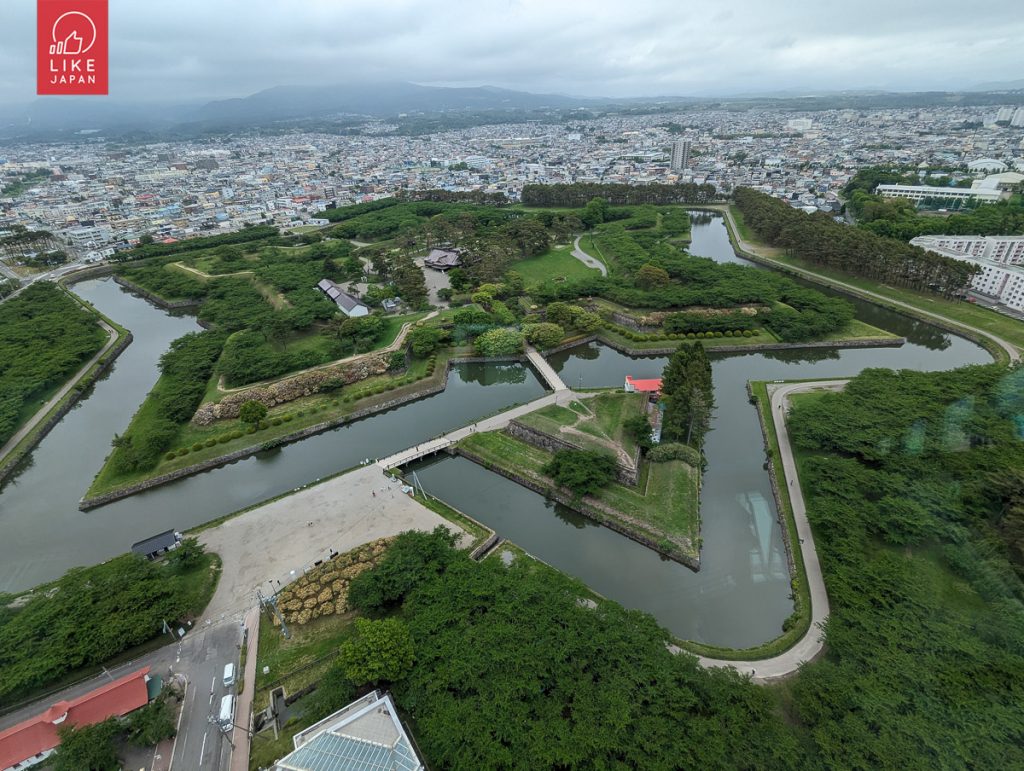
[460,431,700,556]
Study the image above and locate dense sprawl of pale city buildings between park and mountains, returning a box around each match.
[0,102,1024,268]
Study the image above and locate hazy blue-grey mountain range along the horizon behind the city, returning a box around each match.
[0,80,1024,140]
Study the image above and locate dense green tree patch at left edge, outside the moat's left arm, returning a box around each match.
[0,282,106,444]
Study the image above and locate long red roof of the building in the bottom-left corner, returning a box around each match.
[0,667,150,768]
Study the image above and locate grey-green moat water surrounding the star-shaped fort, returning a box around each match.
[0,216,991,647]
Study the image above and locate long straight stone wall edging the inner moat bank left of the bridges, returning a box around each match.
[78,358,499,511]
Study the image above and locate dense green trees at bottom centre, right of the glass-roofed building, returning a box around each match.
[349,528,801,770]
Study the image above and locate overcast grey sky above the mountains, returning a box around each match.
[0,0,1024,103]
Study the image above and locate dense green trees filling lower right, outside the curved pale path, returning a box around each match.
[790,366,1024,768]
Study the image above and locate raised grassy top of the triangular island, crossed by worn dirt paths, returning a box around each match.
[518,393,645,458]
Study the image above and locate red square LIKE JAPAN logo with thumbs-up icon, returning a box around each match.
[36,0,109,95]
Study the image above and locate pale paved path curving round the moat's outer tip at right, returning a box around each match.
[697,380,849,683]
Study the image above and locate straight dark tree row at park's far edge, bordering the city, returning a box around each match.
[521,182,722,204]
